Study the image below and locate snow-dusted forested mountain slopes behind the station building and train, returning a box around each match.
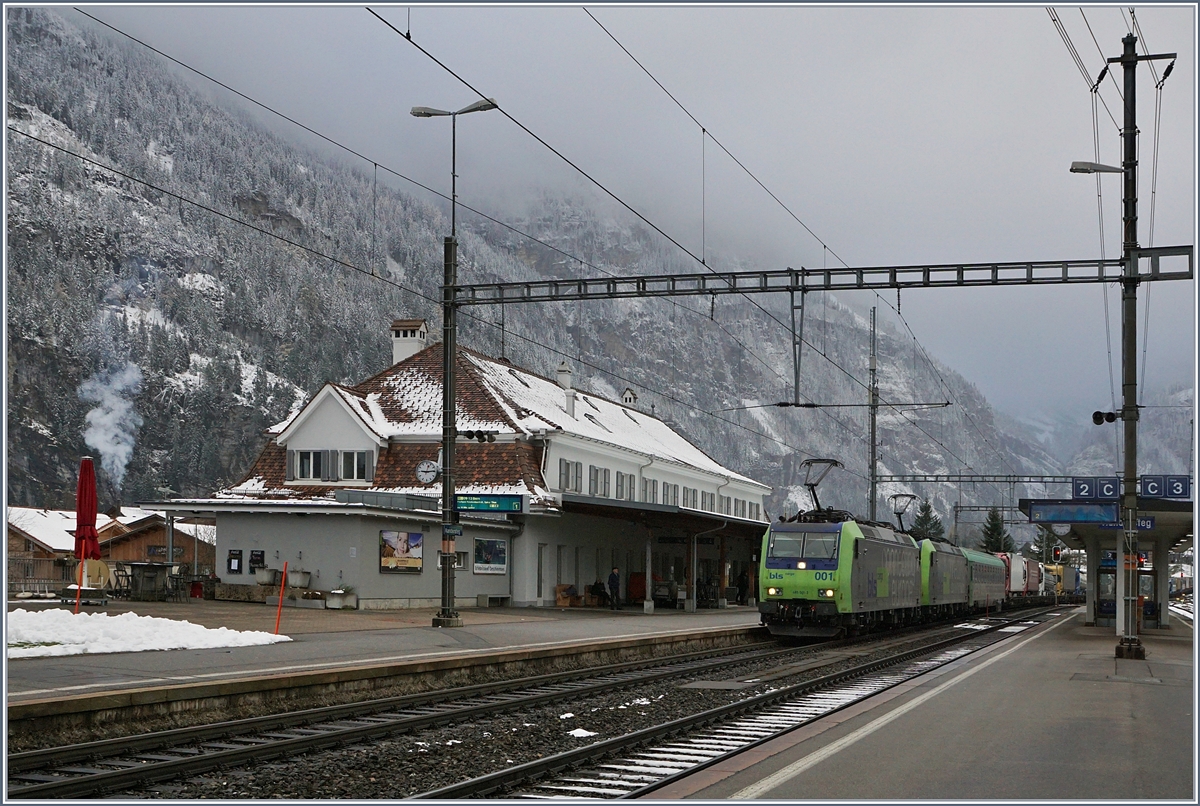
[6,8,1190,534]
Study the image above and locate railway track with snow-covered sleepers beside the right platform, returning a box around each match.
[415,608,1058,800]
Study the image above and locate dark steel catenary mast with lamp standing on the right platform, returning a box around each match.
[1070,34,1175,658]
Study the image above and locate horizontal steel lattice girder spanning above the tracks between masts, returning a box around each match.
[449,246,1194,306]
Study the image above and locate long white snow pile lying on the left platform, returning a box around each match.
[7,608,292,658]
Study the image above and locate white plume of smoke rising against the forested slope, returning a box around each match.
[79,361,142,488]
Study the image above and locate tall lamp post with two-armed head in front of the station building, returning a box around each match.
[412,98,497,627]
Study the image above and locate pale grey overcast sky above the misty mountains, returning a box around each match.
[79,5,1196,421]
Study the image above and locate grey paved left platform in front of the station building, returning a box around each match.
[7,599,758,703]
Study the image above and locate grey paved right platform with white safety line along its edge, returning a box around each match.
[653,609,1196,802]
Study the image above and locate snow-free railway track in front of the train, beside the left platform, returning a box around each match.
[7,642,796,798]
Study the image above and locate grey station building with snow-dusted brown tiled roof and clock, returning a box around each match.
[154,319,770,610]
